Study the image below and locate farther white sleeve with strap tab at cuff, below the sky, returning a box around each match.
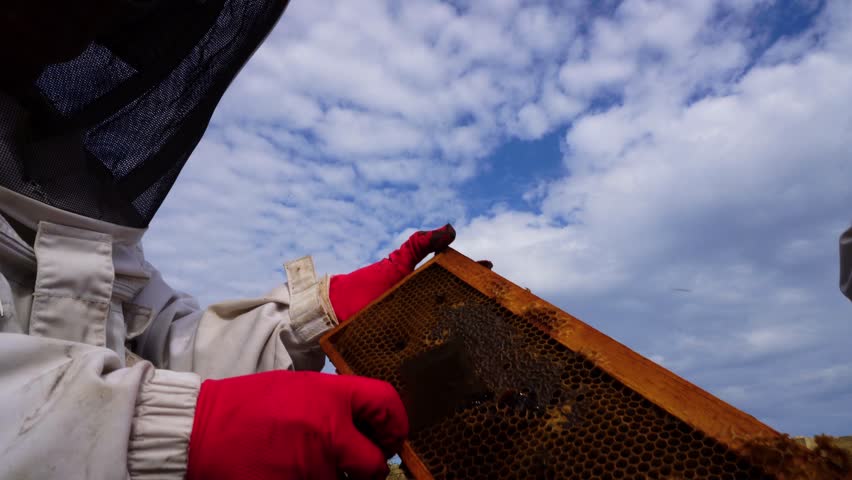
[134,257,337,379]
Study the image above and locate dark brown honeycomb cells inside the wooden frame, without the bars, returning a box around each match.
[331,263,840,480]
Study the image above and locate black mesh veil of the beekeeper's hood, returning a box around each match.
[0,0,287,227]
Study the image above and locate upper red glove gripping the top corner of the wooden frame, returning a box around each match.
[328,223,456,322]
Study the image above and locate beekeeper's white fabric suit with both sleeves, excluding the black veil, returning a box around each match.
[0,98,336,478]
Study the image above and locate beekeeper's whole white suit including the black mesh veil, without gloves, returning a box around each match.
[0,0,352,479]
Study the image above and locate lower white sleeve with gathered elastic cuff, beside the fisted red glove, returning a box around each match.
[0,333,200,479]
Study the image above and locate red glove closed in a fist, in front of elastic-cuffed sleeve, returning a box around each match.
[187,370,408,480]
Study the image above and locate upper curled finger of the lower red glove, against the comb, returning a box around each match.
[340,375,408,456]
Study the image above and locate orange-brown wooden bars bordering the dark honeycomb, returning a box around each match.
[320,248,804,479]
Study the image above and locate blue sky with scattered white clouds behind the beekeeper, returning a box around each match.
[146,0,852,435]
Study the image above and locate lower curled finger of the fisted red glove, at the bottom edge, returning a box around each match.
[337,424,390,480]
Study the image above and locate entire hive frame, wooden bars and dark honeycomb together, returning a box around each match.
[322,250,843,480]
